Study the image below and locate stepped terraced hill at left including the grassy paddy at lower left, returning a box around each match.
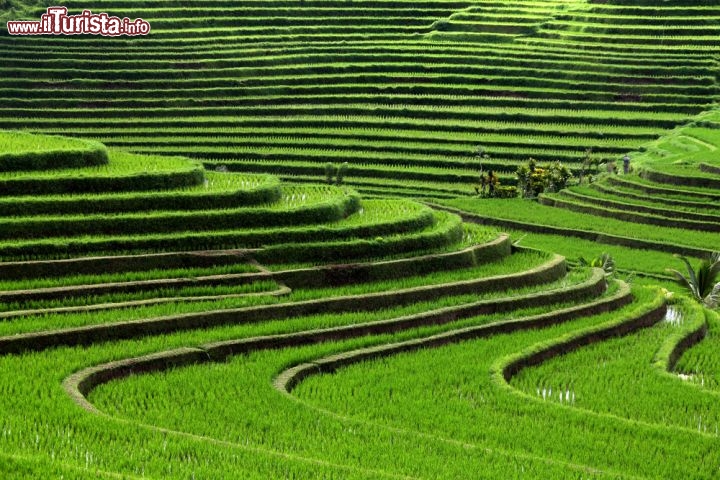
[0,133,616,478]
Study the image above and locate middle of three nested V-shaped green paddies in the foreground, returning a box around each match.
[286,286,712,475]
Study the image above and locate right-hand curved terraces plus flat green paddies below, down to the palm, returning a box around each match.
[438,110,720,276]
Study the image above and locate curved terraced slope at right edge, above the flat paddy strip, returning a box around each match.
[540,124,720,237]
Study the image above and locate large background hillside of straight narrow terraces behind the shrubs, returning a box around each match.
[0,0,720,196]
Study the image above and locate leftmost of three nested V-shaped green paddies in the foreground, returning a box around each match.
[83,284,612,477]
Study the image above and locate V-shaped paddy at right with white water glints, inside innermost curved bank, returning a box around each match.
[512,298,720,430]
